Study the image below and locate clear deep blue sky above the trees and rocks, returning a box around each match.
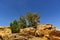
[0,0,60,29]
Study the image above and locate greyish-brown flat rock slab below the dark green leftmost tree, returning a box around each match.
[8,33,33,40]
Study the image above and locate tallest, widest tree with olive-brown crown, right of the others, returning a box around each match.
[26,12,40,27]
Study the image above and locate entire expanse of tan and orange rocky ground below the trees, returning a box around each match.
[0,24,60,40]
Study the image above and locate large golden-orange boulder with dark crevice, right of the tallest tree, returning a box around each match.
[35,24,56,36]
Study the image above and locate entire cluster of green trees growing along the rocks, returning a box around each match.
[10,12,40,33]
